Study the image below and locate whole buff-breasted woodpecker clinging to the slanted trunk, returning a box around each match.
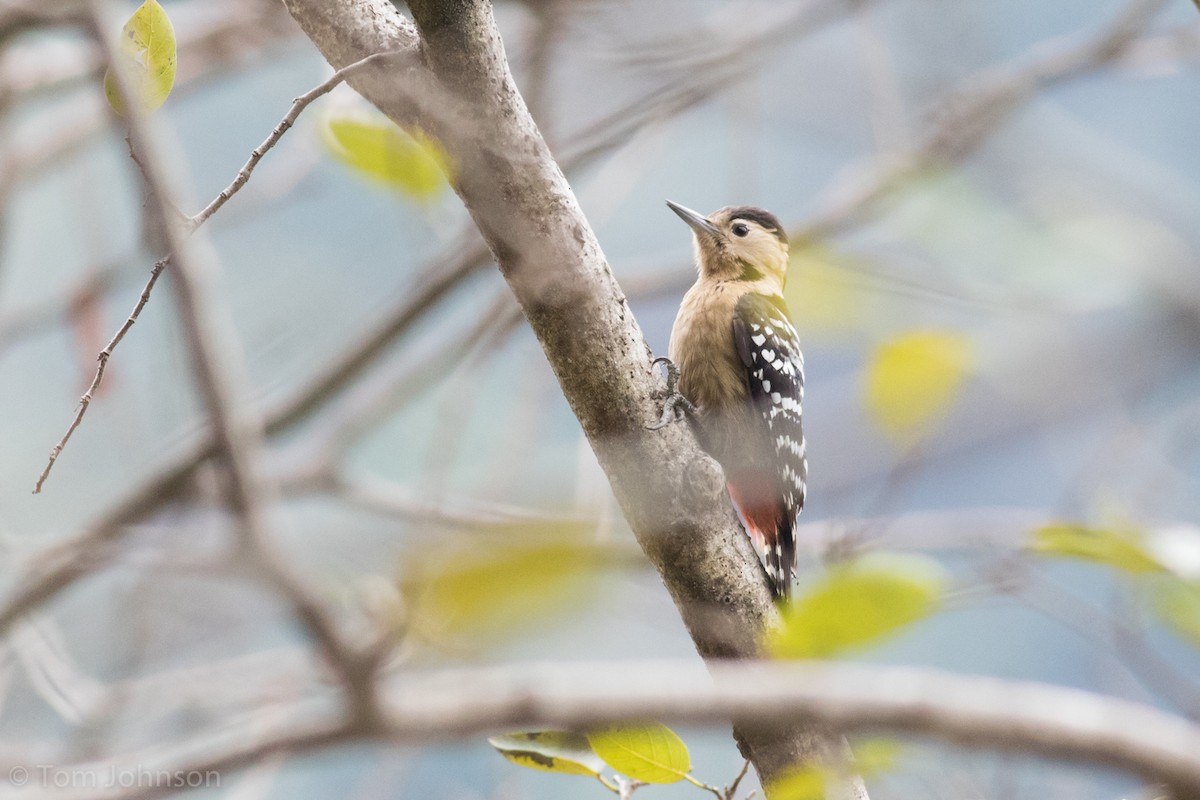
[660,200,809,599]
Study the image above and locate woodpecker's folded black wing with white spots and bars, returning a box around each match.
[733,294,809,587]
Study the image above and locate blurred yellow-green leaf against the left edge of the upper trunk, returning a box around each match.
[322,113,451,200]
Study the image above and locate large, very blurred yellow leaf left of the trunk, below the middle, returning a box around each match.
[400,532,605,645]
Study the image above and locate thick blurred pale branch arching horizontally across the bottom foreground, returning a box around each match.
[46,661,1200,800]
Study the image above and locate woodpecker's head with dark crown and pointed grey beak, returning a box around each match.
[667,200,787,290]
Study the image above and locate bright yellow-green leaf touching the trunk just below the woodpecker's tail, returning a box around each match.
[767,554,947,658]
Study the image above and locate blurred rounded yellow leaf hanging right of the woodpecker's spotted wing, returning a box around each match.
[864,331,970,445]
